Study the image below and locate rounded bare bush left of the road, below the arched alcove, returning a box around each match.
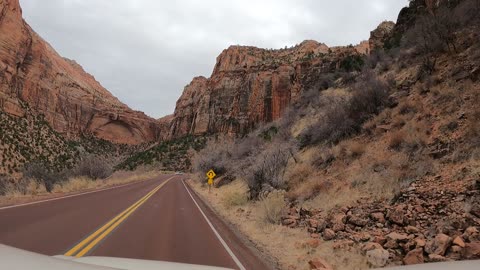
[73,155,113,180]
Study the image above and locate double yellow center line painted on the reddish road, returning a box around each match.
[64,176,174,258]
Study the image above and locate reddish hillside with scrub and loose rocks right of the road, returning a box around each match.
[194,0,480,268]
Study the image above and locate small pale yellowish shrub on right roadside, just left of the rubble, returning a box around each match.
[259,191,287,224]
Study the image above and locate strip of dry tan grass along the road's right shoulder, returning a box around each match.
[189,180,368,270]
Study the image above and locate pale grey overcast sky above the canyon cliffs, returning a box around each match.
[20,0,408,118]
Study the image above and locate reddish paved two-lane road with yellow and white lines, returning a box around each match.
[0,175,270,269]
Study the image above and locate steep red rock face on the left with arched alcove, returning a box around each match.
[0,0,160,144]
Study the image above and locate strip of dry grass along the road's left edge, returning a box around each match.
[0,171,164,205]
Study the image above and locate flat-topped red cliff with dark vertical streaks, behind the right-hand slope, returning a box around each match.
[170,41,368,138]
